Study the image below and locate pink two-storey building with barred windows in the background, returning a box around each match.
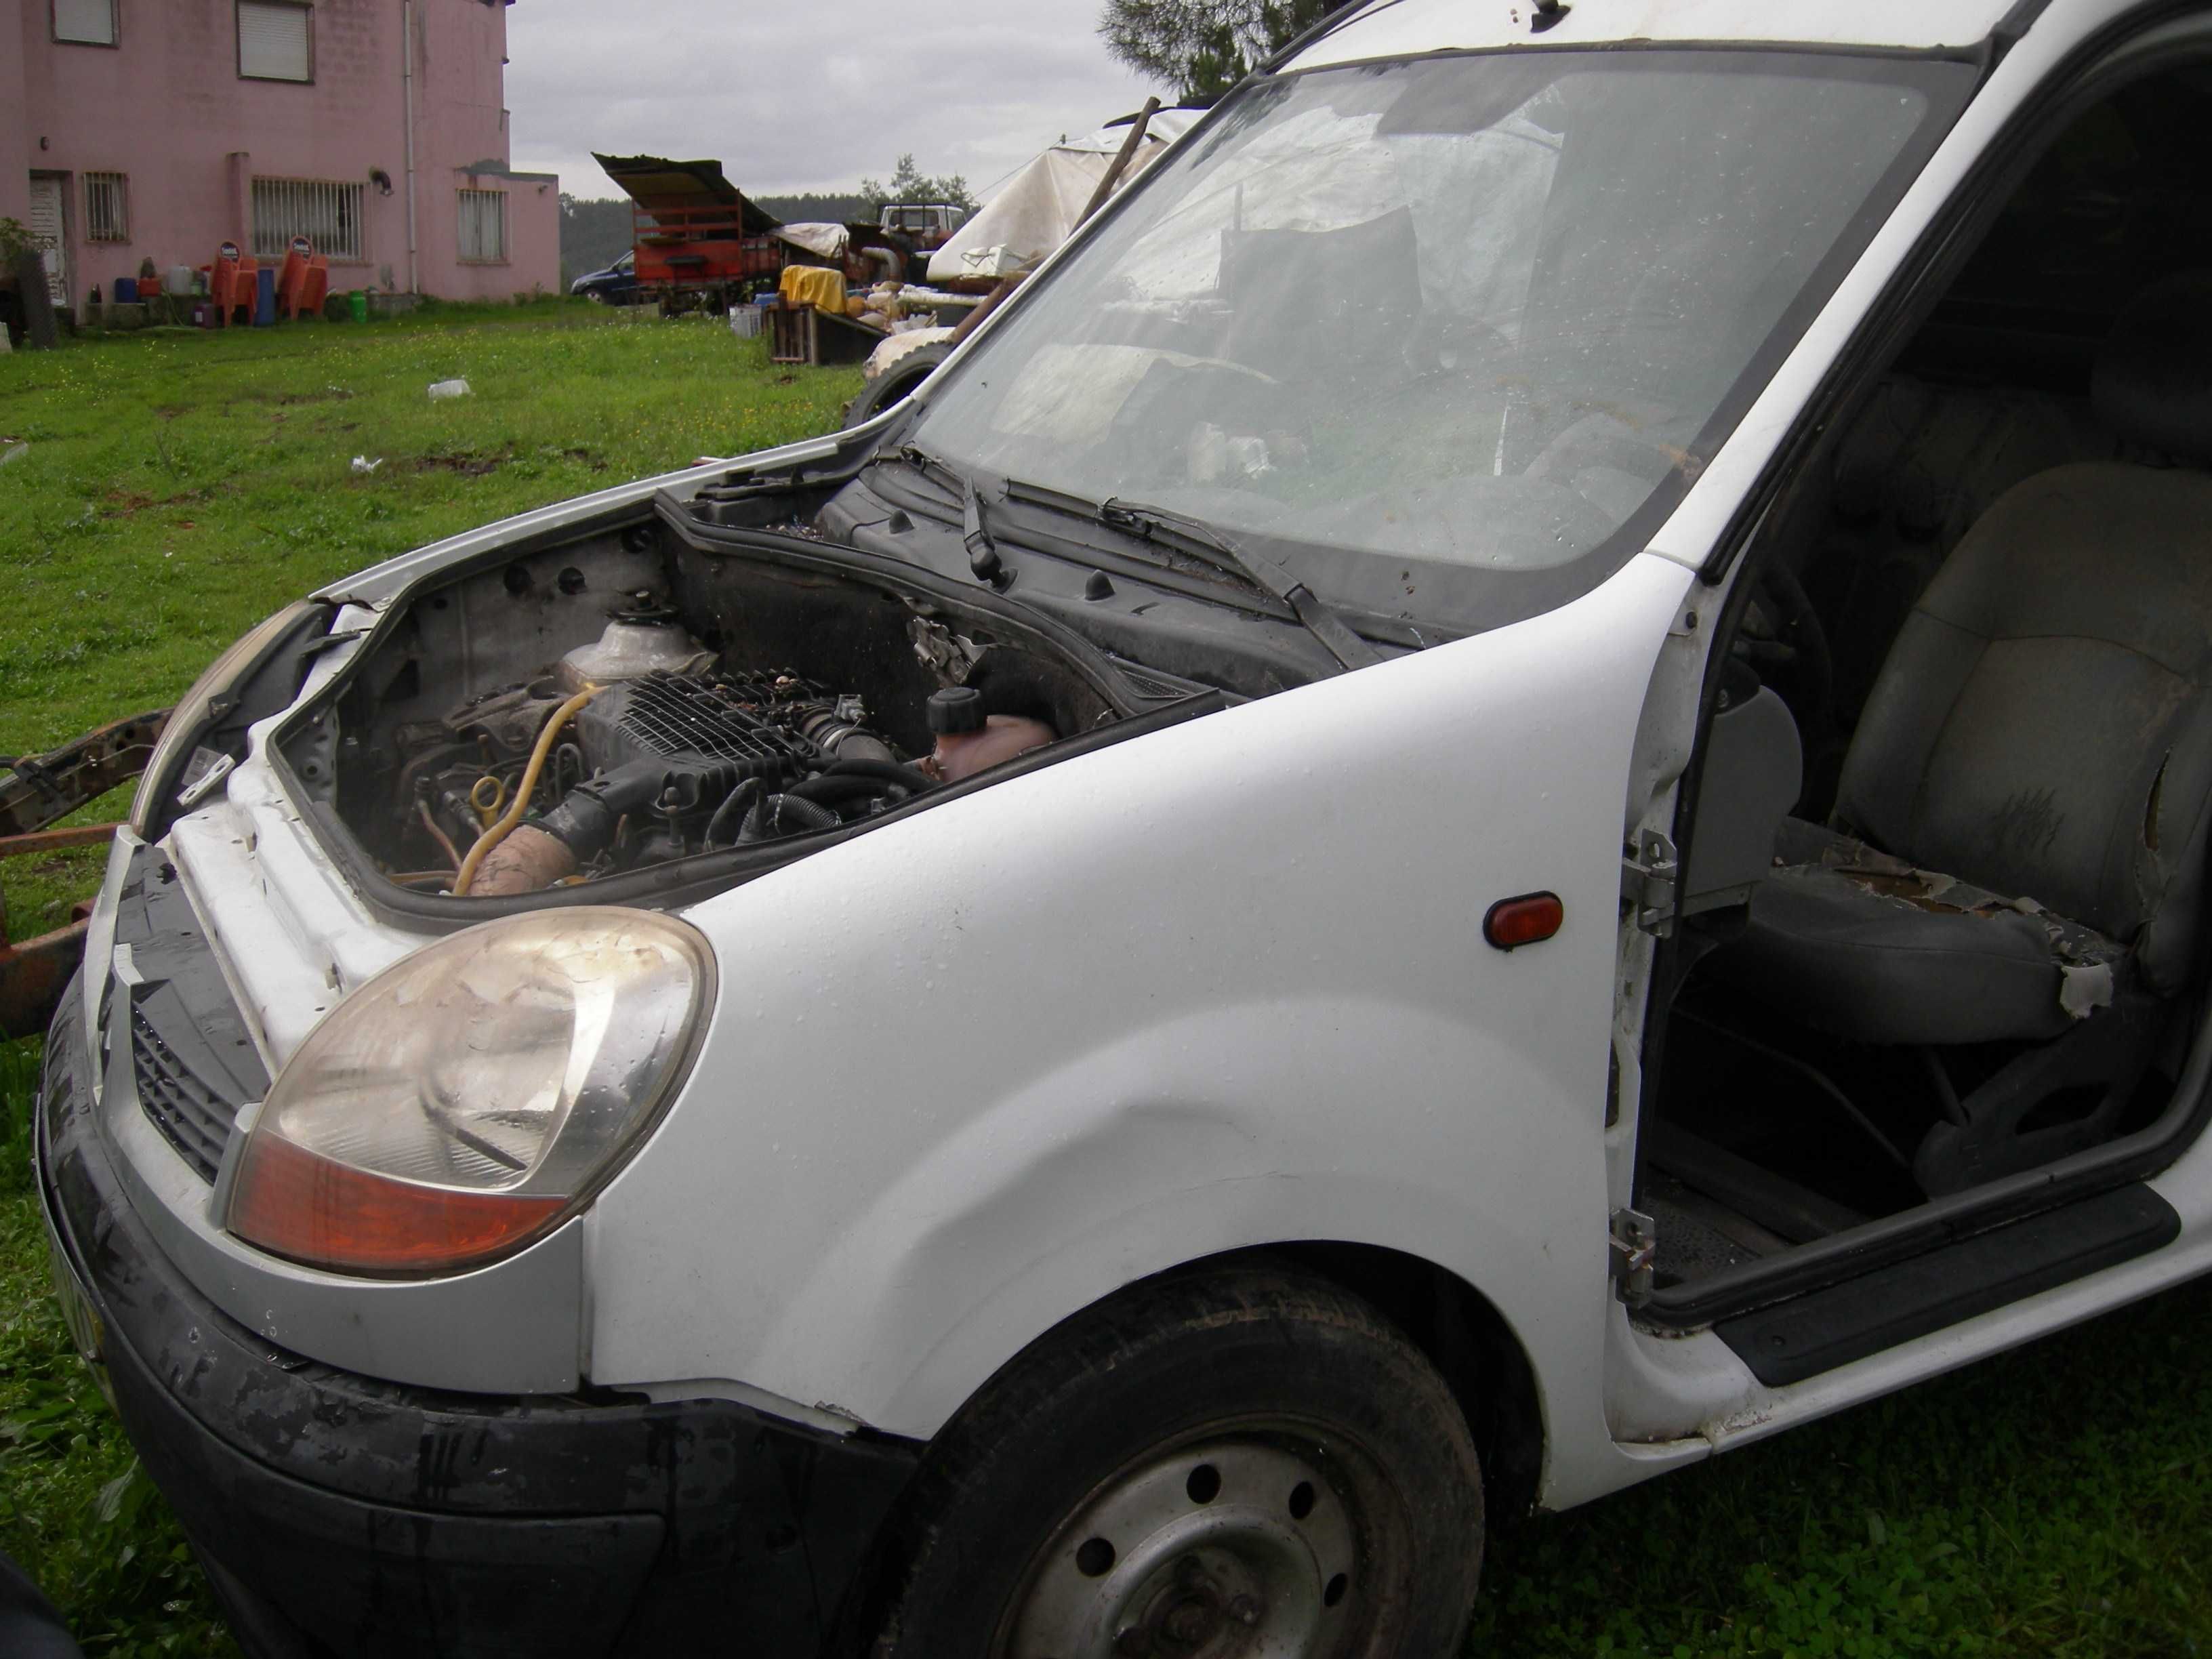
[0,0,560,314]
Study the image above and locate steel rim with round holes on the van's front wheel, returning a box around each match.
[994,1425,1389,1659]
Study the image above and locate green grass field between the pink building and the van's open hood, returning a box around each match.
[0,301,861,940]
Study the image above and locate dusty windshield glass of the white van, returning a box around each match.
[909,51,1971,621]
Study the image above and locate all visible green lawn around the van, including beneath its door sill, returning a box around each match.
[0,305,2212,1659]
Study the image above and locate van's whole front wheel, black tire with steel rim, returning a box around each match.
[865,1267,1482,1659]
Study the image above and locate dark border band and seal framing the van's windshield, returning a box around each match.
[900,44,1980,635]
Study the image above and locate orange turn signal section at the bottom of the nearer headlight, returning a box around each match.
[230,1134,569,1274]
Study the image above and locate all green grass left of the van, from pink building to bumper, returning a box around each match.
[0,301,861,1654]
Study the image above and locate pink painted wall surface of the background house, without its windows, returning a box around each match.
[13,0,560,314]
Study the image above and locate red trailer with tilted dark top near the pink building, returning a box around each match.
[593,152,787,312]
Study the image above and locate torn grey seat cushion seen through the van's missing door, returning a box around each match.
[1708,819,2126,1044]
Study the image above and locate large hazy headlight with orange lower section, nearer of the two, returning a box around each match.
[226,905,714,1274]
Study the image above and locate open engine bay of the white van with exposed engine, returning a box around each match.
[279,518,1195,898]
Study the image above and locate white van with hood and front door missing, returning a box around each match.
[37,0,2212,1659]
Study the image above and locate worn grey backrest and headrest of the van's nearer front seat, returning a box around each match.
[1836,276,2212,989]
